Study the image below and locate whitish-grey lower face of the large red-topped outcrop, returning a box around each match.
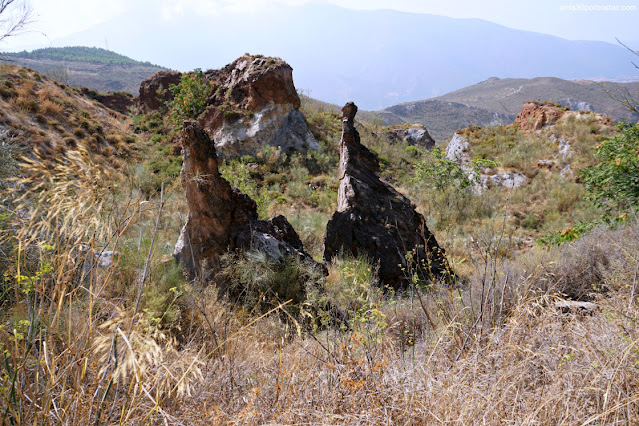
[212,104,321,158]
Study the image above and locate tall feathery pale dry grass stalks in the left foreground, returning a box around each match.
[0,149,201,424]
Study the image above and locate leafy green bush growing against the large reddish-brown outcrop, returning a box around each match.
[167,68,211,127]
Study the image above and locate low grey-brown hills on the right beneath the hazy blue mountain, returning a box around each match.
[376,77,639,141]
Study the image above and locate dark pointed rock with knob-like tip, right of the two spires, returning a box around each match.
[324,102,452,289]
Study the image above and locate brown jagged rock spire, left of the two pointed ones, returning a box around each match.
[174,122,314,280]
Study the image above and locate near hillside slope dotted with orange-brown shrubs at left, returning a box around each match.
[0,65,137,181]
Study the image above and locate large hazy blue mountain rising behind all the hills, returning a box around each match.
[46,2,637,110]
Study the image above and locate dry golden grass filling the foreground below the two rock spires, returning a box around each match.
[0,146,639,424]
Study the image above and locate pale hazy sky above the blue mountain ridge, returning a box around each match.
[5,0,639,50]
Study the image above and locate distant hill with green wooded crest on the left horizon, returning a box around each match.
[0,46,165,95]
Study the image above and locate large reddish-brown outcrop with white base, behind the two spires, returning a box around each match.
[198,56,321,157]
